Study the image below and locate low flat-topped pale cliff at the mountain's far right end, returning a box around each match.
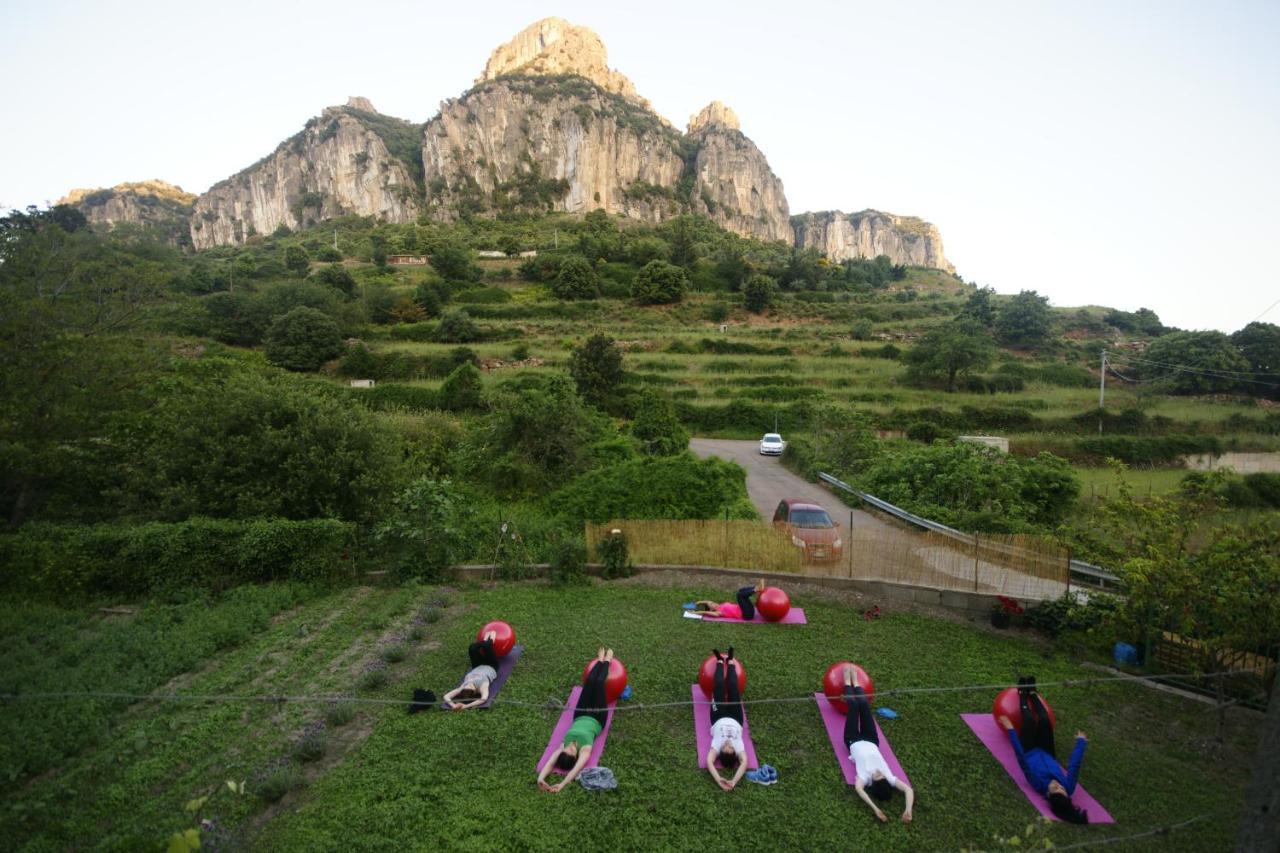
[791,210,955,273]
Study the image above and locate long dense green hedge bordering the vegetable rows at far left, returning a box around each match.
[0,519,355,597]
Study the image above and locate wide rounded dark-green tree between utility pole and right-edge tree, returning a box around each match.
[1138,326,1252,394]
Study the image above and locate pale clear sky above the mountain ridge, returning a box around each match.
[0,0,1280,332]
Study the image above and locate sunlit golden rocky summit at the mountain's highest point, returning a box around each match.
[476,18,646,102]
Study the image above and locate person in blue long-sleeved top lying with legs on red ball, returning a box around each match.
[1000,675,1089,824]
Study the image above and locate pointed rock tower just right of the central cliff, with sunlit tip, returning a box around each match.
[687,101,792,242]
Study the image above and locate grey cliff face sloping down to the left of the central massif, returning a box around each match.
[191,99,420,248]
